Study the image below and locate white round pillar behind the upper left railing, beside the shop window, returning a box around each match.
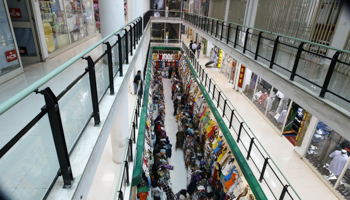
[99,0,125,41]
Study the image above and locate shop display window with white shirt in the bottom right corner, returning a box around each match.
[305,121,350,199]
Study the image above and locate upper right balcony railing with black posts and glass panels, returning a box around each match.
[183,13,350,110]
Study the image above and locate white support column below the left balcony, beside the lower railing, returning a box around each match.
[110,87,130,164]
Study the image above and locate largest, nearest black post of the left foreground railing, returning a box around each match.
[39,87,73,188]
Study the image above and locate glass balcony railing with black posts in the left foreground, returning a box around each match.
[0,18,143,199]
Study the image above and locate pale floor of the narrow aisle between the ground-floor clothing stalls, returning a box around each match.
[163,78,187,193]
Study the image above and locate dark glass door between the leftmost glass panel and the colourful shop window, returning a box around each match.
[7,0,41,62]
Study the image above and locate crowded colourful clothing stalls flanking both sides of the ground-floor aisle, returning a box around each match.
[138,51,254,200]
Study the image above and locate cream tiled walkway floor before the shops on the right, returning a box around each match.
[182,36,338,200]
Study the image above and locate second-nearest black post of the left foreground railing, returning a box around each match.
[83,56,101,126]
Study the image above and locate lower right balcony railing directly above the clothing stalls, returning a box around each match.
[182,43,301,200]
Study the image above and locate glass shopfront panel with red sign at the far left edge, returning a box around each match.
[0,1,23,83]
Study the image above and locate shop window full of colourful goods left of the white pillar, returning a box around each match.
[39,0,96,53]
